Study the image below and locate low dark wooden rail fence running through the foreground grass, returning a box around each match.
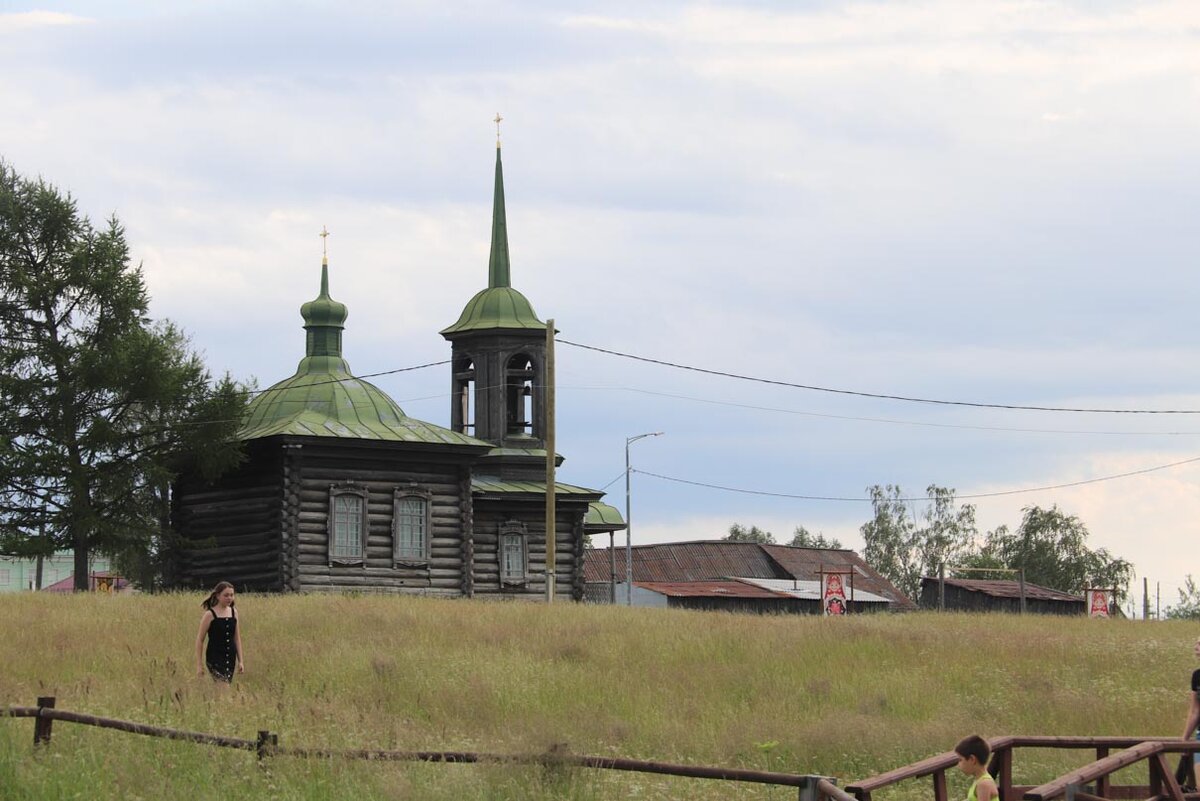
[0,697,856,801]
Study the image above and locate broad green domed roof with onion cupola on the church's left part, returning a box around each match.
[238,264,491,448]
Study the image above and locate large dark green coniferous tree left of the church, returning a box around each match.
[0,161,245,590]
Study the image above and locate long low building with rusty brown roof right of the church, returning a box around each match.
[583,540,917,614]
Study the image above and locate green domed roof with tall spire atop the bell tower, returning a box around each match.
[442,146,546,336]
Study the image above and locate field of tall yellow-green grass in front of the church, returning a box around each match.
[0,594,1200,801]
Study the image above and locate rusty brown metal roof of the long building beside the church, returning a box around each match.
[583,540,917,609]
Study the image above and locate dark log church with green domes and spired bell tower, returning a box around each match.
[168,143,616,600]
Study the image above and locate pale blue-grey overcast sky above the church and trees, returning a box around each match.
[0,0,1200,606]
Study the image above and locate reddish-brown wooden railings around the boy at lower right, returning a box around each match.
[846,735,1200,801]
